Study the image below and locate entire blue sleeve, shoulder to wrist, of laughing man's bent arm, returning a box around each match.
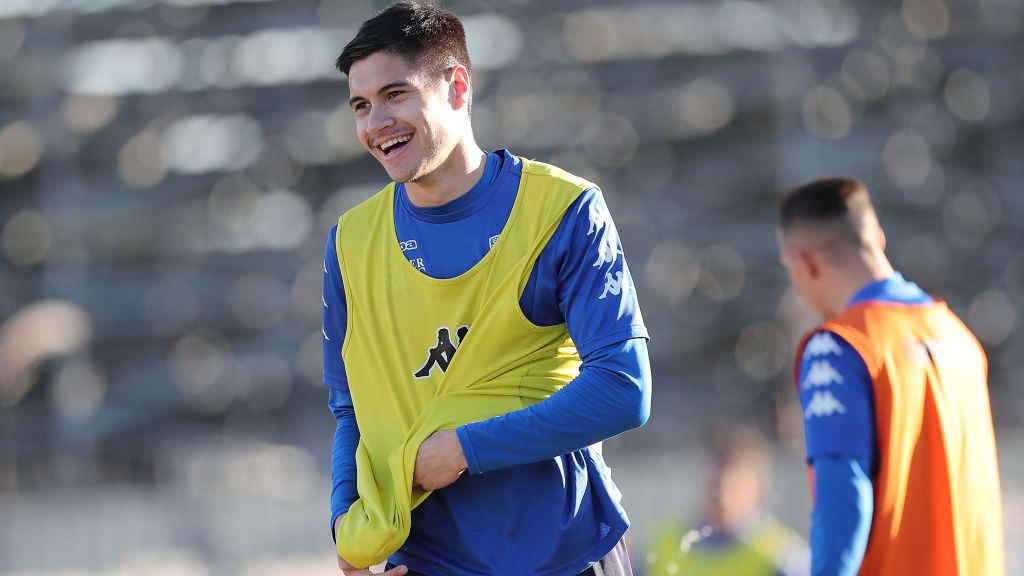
[448,189,651,474]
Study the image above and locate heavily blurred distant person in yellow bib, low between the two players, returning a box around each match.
[644,426,809,576]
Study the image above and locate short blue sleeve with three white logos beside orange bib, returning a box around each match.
[799,331,876,464]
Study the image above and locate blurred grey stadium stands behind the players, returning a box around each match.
[0,0,1024,576]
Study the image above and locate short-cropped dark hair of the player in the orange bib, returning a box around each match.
[778,176,878,245]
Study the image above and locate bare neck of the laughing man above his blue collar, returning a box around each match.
[406,140,487,208]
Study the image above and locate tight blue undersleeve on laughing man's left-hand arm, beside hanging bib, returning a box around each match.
[328,388,359,534]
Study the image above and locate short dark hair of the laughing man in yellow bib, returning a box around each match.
[335,2,472,75]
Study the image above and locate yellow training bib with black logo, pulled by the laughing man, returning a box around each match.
[337,160,594,567]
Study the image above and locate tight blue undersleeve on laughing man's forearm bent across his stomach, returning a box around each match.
[457,338,650,474]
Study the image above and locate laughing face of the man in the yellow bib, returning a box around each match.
[348,52,461,182]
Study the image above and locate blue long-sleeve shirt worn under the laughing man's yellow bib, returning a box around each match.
[324,151,650,574]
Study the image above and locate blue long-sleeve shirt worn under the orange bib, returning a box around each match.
[799,274,933,576]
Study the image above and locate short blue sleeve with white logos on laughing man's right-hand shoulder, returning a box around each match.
[519,189,647,358]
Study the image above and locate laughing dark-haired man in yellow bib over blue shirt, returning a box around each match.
[324,3,650,576]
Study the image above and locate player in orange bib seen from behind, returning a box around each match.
[778,177,1005,576]
